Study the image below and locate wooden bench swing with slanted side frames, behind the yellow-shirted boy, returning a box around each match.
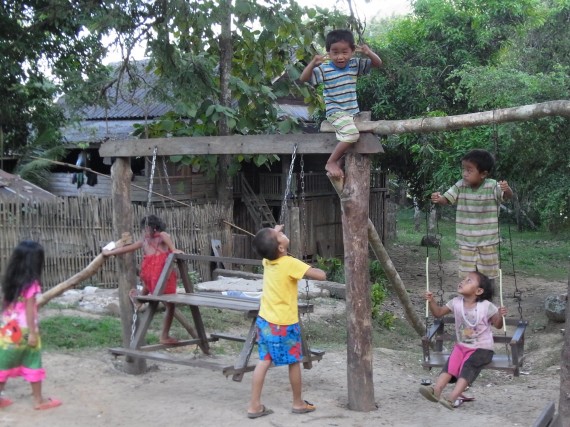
[109,254,324,381]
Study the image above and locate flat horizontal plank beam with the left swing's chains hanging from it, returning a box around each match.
[99,133,384,157]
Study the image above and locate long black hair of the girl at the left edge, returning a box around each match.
[2,240,45,308]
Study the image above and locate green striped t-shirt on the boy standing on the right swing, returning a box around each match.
[443,179,503,247]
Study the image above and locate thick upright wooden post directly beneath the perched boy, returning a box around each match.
[341,154,377,411]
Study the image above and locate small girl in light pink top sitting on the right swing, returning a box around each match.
[420,271,507,409]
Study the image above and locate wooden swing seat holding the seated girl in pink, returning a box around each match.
[422,317,528,377]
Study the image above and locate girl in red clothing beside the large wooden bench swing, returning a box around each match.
[103,215,182,344]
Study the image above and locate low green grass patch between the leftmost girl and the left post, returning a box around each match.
[40,316,122,350]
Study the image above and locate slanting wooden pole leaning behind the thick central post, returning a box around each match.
[331,179,426,337]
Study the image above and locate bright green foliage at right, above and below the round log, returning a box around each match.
[358,0,570,230]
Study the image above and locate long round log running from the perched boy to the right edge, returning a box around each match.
[321,100,570,135]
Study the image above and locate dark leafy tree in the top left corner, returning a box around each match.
[0,0,108,181]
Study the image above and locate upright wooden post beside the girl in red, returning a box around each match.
[111,158,146,374]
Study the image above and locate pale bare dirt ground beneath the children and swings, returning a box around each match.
[0,242,567,427]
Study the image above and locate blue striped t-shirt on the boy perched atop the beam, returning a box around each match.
[311,58,372,117]
